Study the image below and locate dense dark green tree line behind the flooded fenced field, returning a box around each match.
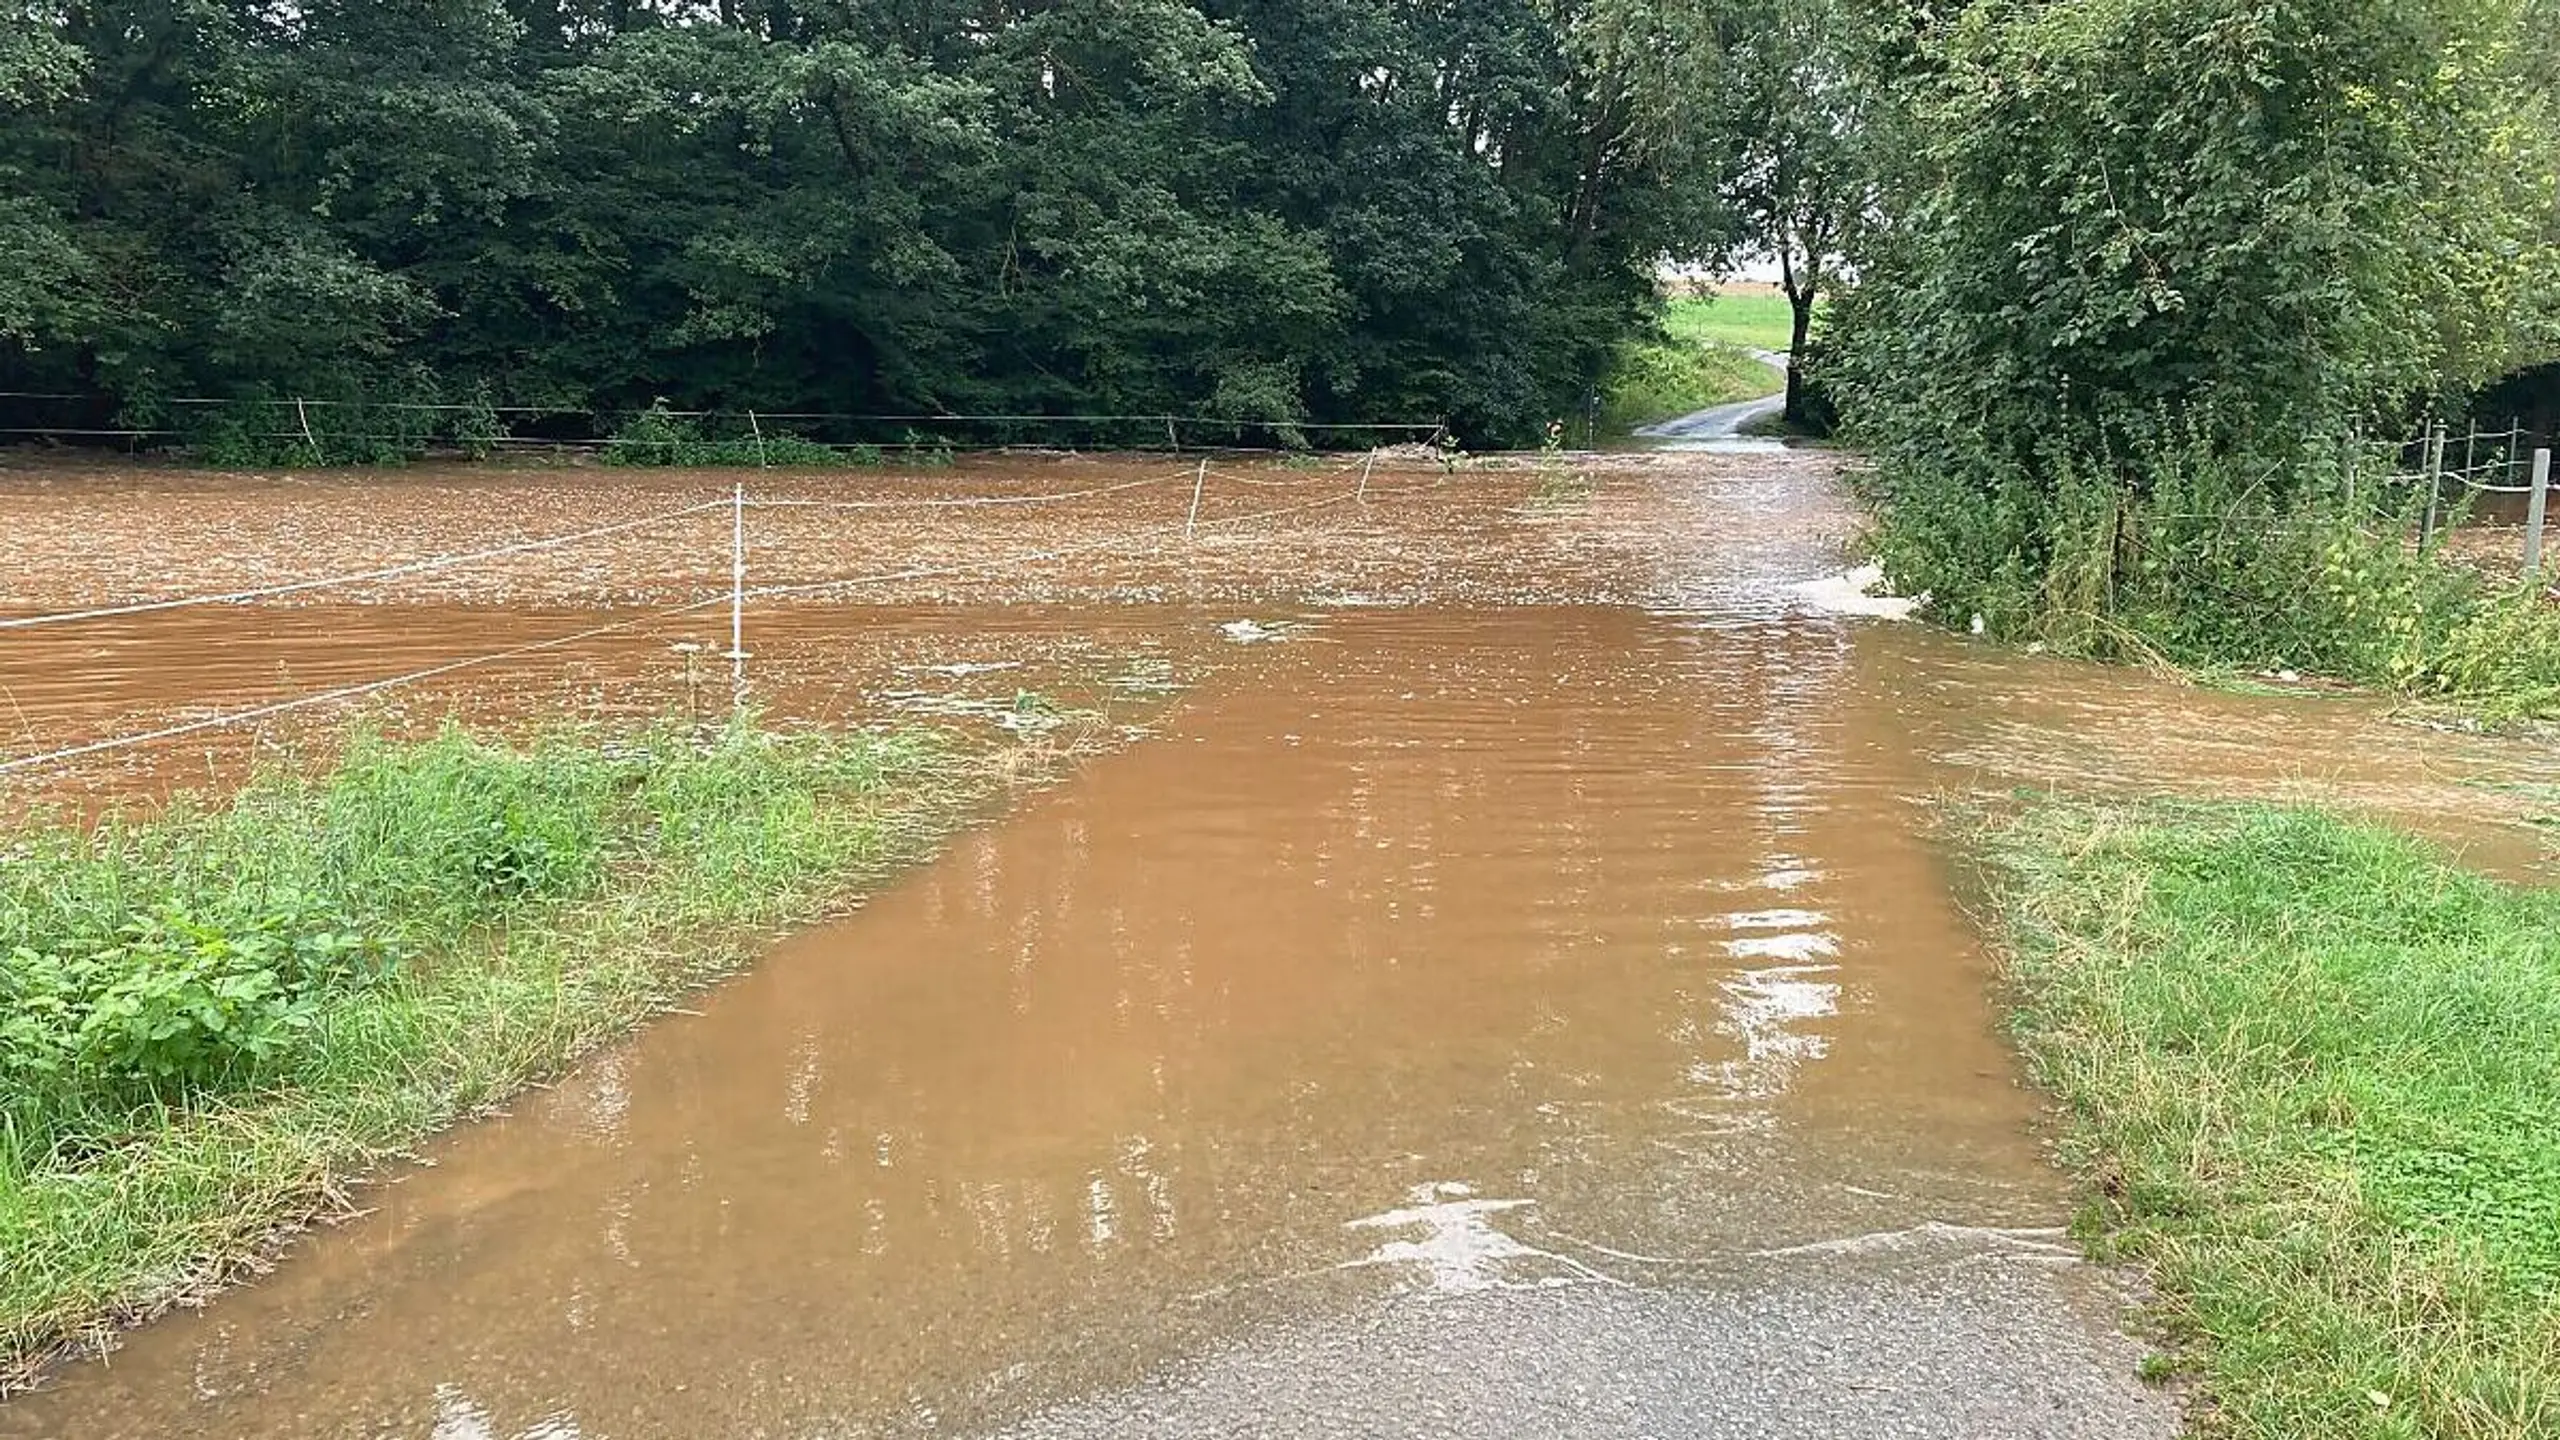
[0,0,1702,438]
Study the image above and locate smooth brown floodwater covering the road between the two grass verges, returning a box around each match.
[0,607,2181,1437]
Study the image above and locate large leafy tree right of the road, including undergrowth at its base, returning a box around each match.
[1823,0,2560,710]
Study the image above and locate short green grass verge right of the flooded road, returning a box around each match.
[1984,805,2560,1440]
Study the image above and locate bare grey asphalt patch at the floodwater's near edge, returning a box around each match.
[1009,1209,2179,1440]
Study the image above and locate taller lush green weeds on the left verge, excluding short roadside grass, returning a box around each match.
[0,735,634,1143]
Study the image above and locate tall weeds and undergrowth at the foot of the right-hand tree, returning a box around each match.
[1869,423,2560,717]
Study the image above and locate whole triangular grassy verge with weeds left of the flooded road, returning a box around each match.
[0,723,1054,1391]
